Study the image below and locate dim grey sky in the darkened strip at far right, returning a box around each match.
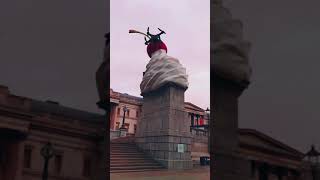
[225,0,320,152]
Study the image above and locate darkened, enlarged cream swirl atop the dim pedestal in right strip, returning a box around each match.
[211,0,252,85]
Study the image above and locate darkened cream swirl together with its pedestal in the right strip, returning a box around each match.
[210,0,251,180]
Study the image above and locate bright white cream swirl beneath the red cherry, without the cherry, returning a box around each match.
[140,49,189,94]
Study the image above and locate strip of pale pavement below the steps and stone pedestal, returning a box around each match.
[110,166,210,180]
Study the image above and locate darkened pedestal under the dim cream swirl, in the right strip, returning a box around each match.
[211,76,251,180]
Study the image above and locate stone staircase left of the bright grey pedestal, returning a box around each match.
[110,137,164,173]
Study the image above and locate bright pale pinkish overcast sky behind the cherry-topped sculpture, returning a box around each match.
[110,0,210,108]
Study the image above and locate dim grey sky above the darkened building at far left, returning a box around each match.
[0,0,108,112]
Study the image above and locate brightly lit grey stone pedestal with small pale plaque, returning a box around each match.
[136,84,193,169]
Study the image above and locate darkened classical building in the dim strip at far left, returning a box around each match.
[0,86,105,180]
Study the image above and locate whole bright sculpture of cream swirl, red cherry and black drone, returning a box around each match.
[129,28,189,95]
